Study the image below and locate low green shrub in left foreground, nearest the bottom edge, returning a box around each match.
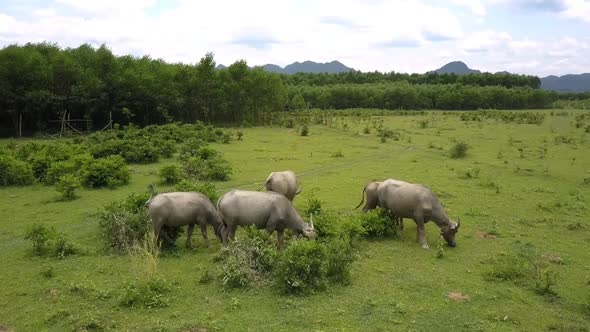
[119,277,170,309]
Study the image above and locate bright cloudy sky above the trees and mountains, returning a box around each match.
[0,0,590,76]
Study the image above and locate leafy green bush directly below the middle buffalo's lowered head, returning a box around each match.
[275,240,328,293]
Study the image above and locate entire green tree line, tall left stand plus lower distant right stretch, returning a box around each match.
[0,43,584,136]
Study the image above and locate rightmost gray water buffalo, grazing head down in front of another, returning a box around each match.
[377,181,461,249]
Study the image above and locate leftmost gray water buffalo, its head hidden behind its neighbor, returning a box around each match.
[146,192,227,247]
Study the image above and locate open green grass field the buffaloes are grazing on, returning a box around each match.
[0,111,590,331]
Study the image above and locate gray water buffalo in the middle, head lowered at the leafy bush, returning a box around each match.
[217,190,316,247]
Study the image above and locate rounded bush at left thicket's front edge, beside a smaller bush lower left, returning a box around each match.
[81,156,129,188]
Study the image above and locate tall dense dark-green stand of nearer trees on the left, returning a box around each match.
[0,43,287,136]
